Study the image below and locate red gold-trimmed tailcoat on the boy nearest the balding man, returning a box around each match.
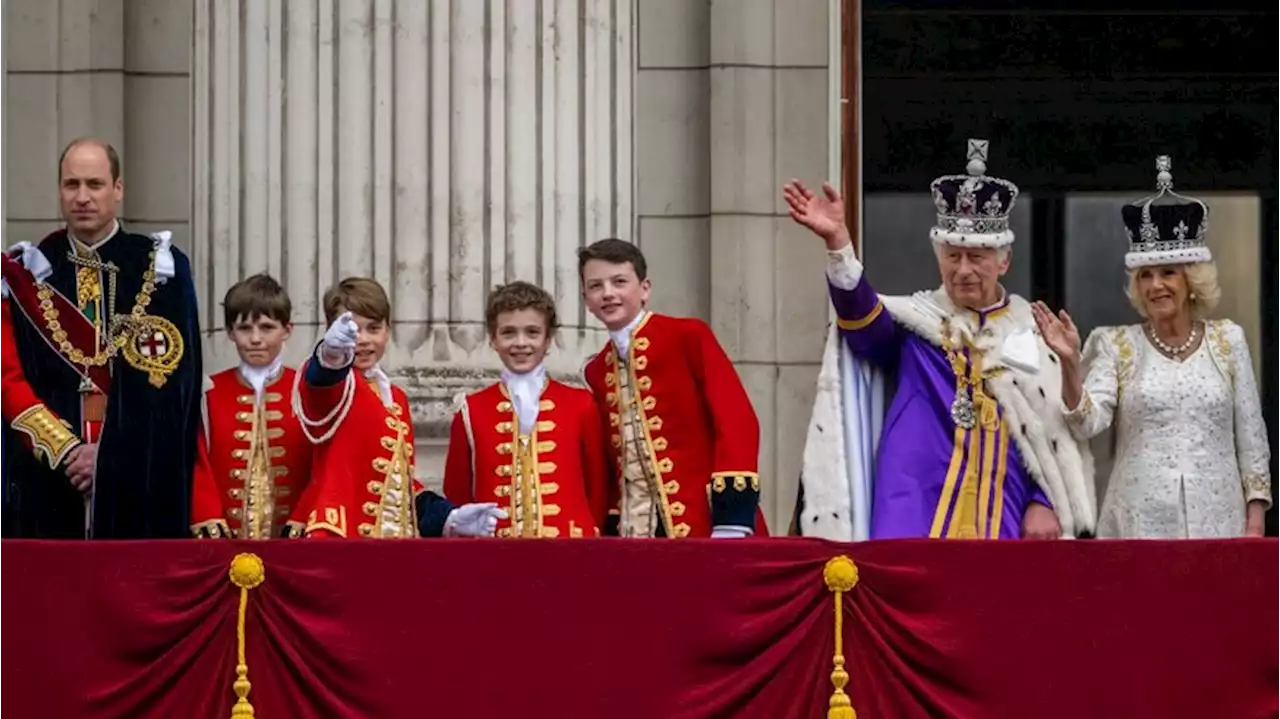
[191,367,312,539]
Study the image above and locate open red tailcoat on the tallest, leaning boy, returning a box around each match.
[584,312,765,537]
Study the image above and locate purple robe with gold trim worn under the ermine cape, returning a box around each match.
[828,278,1052,539]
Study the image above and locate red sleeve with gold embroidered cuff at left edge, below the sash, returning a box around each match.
[0,299,81,470]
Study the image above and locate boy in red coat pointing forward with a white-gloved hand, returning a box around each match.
[293,278,507,539]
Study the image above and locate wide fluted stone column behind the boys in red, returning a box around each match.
[192,0,632,475]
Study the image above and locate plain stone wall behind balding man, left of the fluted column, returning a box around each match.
[0,0,191,248]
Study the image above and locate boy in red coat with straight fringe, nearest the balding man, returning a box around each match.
[191,275,312,539]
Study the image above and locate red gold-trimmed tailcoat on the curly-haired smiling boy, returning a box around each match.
[444,380,609,537]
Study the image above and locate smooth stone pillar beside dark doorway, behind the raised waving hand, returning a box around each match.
[709,0,840,533]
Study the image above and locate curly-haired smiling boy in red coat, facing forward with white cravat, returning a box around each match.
[444,281,608,537]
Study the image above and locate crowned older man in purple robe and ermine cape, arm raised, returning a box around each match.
[783,139,1096,541]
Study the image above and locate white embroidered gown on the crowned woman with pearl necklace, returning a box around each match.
[1066,321,1271,539]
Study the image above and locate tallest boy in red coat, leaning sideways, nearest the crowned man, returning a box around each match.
[577,239,765,537]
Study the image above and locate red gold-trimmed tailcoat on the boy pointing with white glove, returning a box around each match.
[297,358,422,537]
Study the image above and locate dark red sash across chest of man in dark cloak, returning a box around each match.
[0,253,111,394]
